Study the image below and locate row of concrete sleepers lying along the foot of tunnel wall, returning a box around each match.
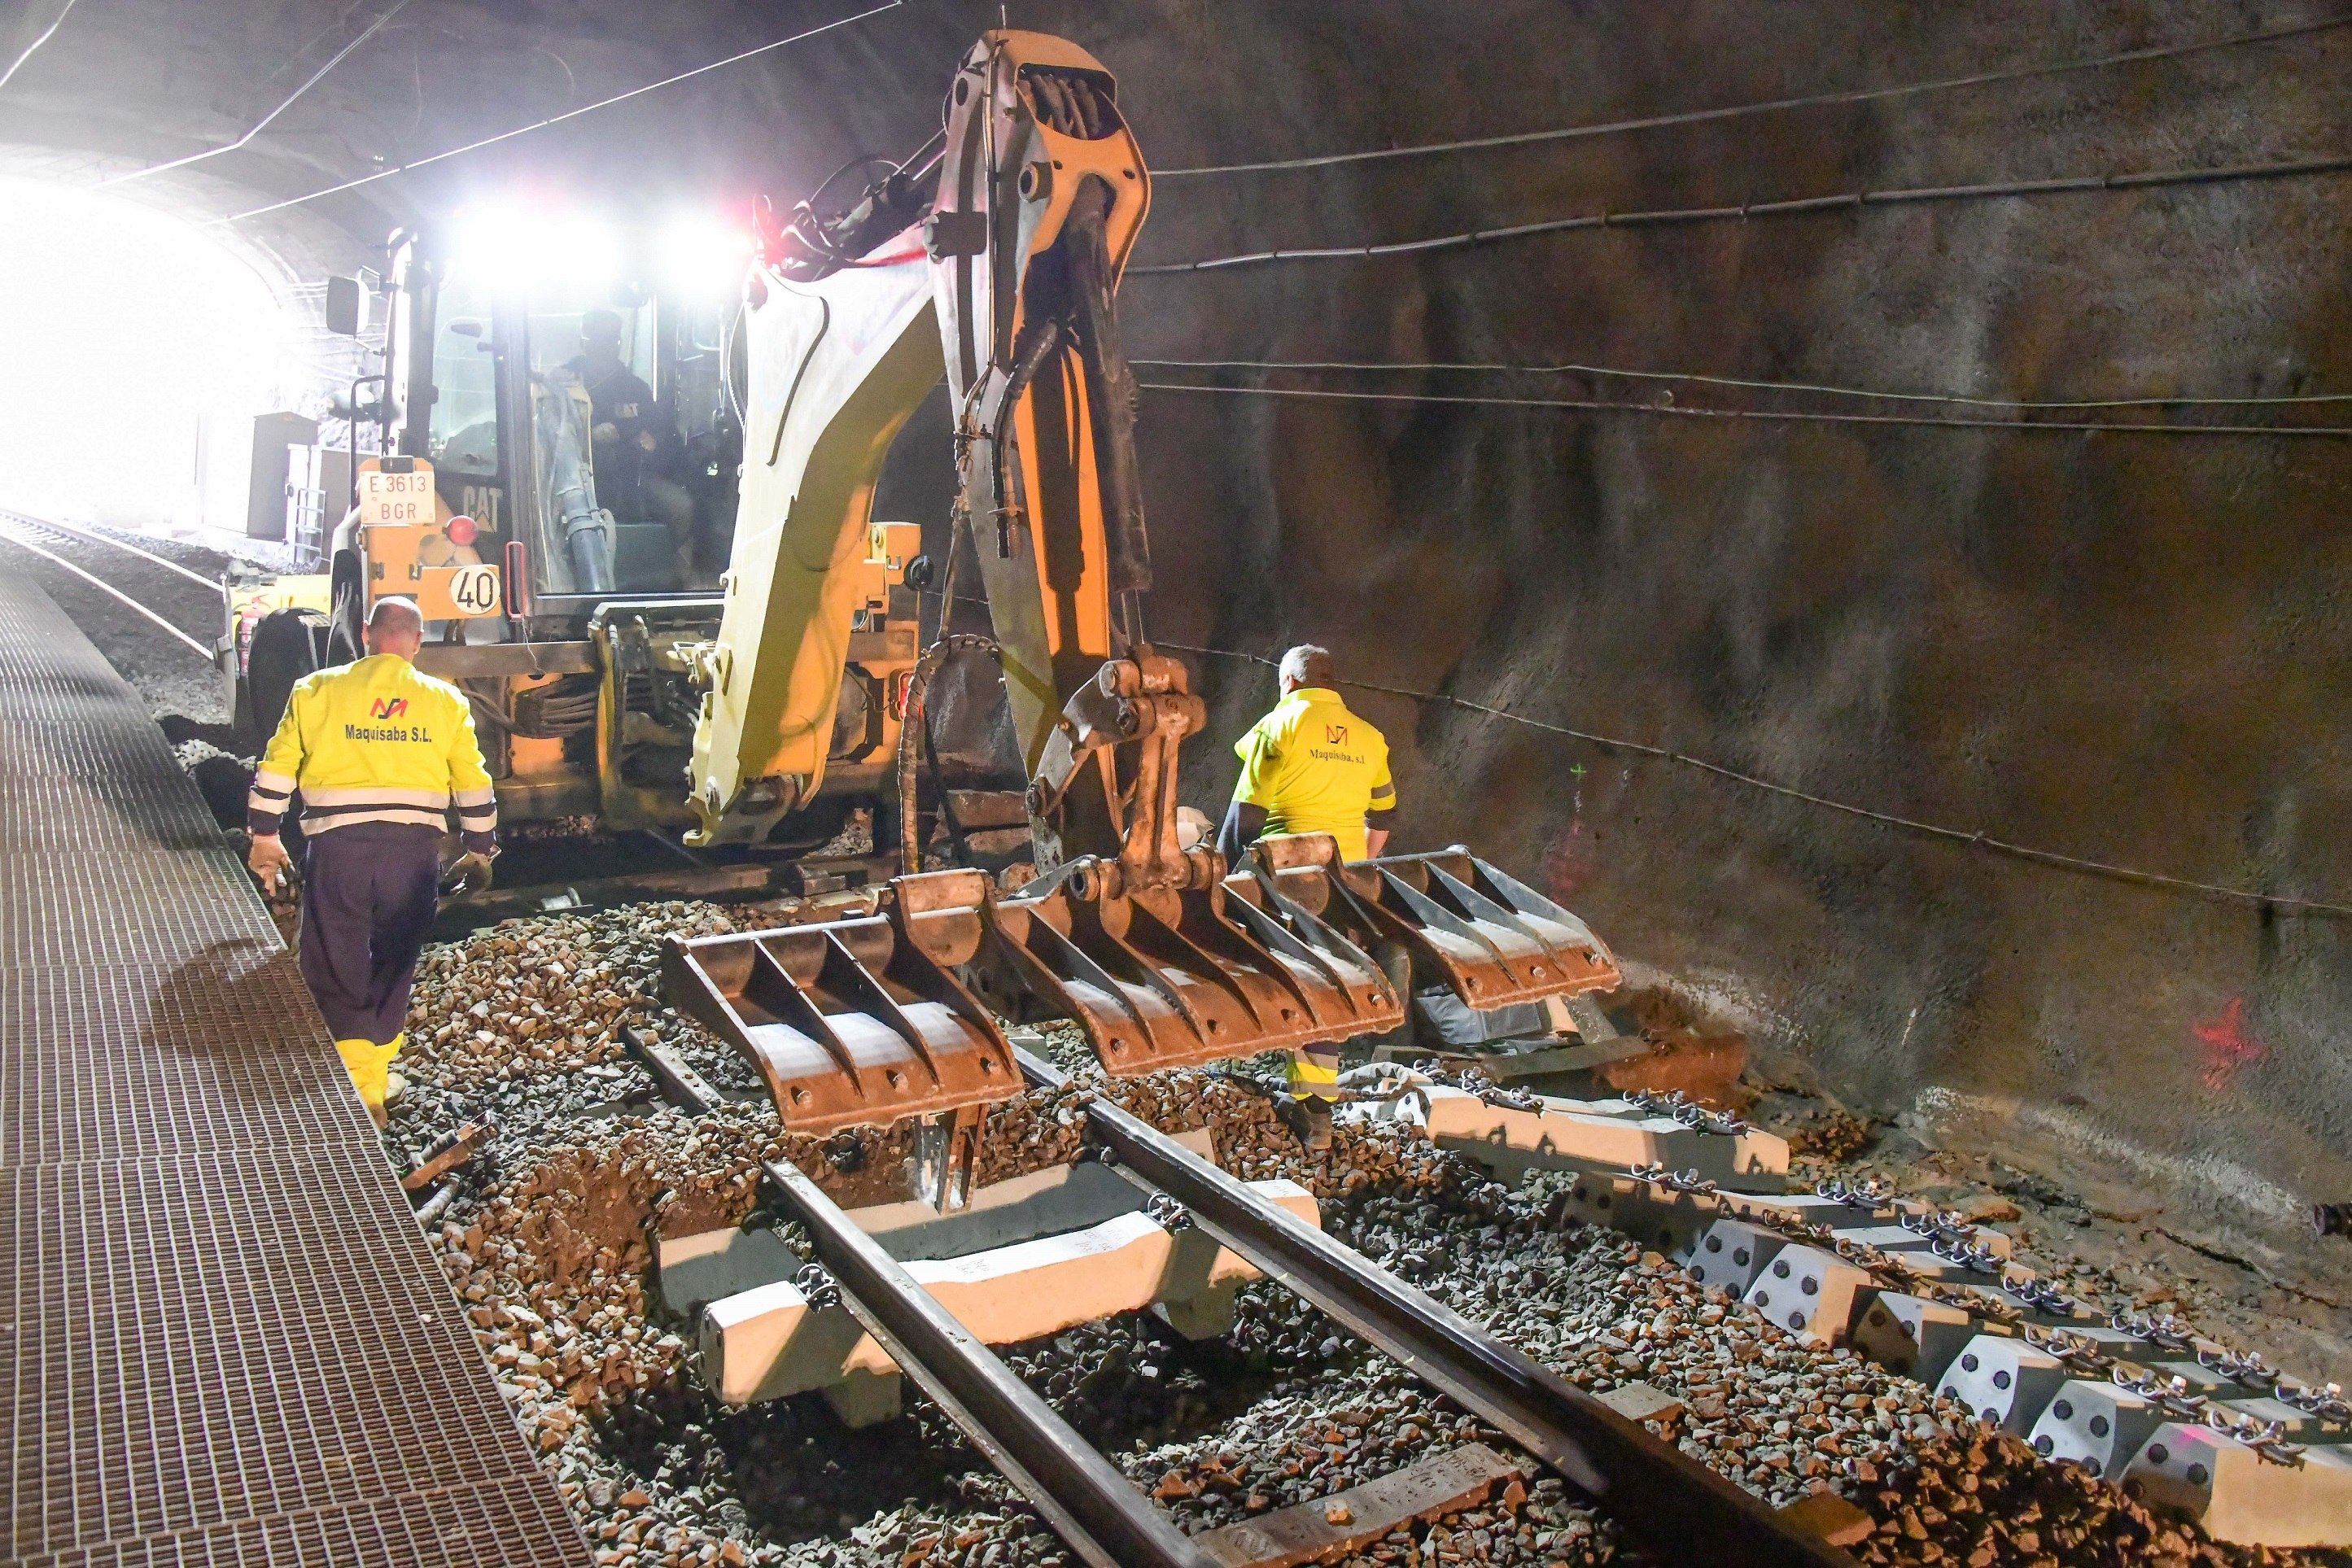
[1354,1079,2352,1547]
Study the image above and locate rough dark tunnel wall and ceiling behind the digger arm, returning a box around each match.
[0,0,2352,1218]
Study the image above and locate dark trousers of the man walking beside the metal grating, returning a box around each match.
[301,823,442,1046]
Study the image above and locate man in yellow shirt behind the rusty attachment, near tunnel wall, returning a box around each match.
[1216,644,1397,1150]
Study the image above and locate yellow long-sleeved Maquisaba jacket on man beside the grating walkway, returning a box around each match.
[245,653,499,854]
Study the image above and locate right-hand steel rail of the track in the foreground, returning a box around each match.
[1086,1098,1853,1568]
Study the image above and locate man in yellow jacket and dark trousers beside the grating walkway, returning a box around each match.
[247,600,499,1126]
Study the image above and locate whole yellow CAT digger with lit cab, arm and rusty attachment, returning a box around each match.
[233,31,1618,1208]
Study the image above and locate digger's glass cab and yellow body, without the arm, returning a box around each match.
[228,219,920,846]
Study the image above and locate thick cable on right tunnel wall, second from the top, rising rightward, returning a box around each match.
[1126,153,2352,277]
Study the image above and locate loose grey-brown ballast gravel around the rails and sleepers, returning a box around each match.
[388,902,2336,1568]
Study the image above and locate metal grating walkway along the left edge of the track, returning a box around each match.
[0,576,590,1568]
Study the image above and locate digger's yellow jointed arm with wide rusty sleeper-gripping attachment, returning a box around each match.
[663,31,1618,1208]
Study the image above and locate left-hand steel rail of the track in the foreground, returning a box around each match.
[759,1161,1218,1568]
